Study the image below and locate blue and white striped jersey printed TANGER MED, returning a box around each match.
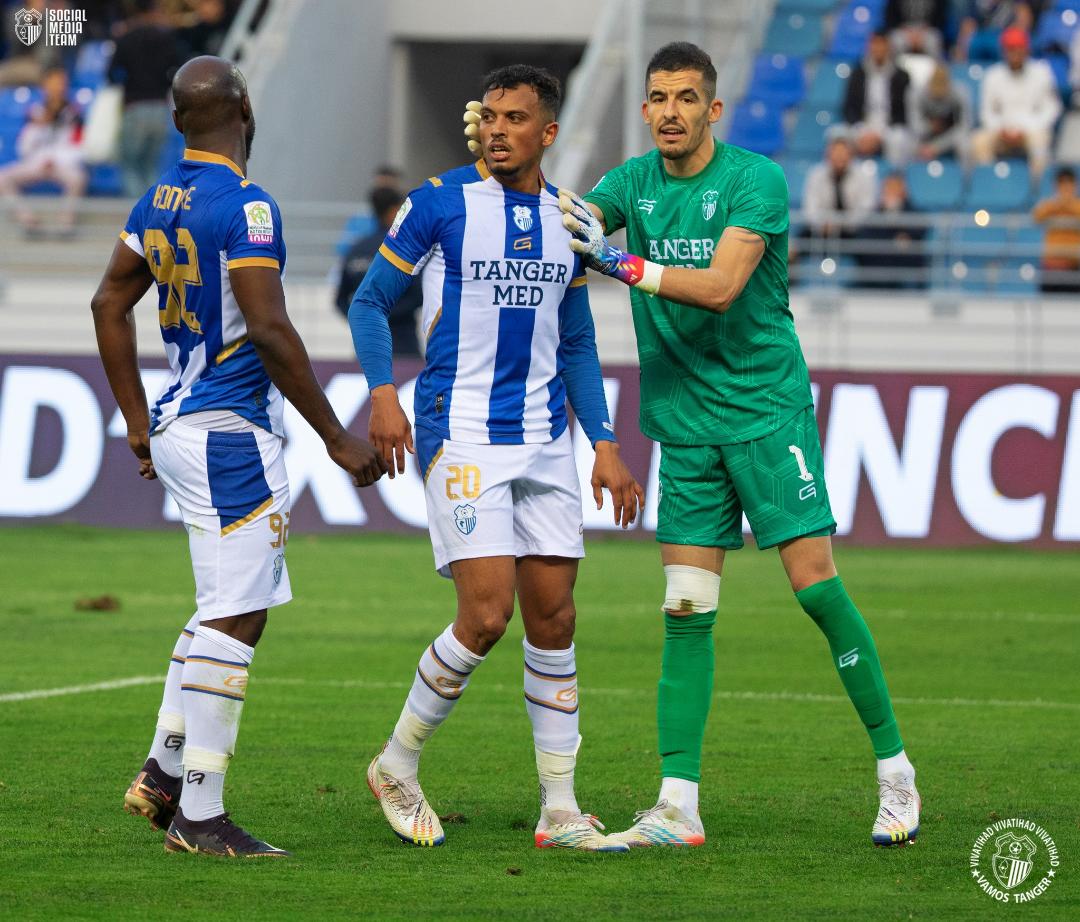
[378,161,610,445]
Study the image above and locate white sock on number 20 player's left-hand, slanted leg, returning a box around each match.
[379,624,484,781]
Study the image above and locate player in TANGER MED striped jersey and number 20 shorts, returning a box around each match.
[349,66,644,851]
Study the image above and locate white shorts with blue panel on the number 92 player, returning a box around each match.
[150,420,293,621]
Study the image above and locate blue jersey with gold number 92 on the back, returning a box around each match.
[121,149,285,435]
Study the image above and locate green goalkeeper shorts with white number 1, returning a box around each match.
[657,407,836,551]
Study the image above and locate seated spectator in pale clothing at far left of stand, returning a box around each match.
[0,67,86,235]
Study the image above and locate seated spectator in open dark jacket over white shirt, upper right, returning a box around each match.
[843,31,910,163]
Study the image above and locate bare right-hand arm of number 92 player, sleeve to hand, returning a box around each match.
[229,266,387,487]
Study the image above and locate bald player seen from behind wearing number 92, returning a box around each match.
[92,57,386,857]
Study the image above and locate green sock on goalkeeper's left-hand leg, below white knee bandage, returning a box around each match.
[657,611,716,783]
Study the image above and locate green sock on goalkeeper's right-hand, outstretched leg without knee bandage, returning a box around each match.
[795,577,904,759]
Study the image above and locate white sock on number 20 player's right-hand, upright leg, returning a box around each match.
[522,640,581,813]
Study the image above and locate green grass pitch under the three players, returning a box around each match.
[0,527,1080,920]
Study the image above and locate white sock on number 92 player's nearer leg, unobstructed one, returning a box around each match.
[180,626,255,819]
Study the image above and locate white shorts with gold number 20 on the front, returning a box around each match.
[417,430,585,577]
